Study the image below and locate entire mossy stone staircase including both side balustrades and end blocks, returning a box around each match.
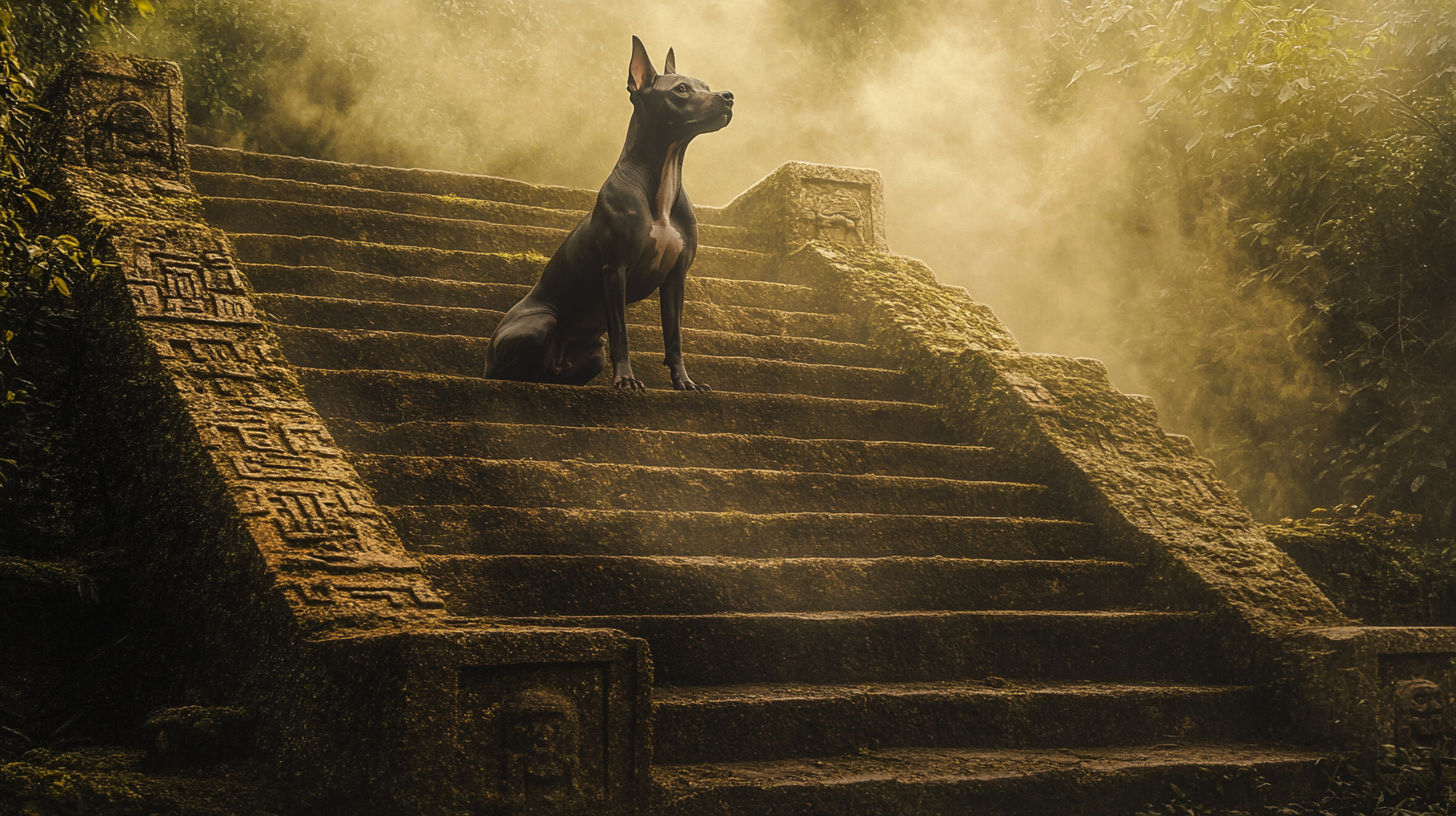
[36,46,1432,816]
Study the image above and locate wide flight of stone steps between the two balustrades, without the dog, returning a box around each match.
[192,147,1315,815]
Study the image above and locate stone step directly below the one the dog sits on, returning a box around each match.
[329,420,1015,481]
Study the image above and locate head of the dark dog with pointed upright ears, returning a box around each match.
[628,36,732,140]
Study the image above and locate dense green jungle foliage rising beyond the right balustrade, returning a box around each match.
[1038,0,1456,532]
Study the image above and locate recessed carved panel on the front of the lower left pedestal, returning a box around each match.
[456,663,607,815]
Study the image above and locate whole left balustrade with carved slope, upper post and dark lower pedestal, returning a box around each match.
[38,52,649,815]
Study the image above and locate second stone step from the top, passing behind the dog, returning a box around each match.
[192,172,757,249]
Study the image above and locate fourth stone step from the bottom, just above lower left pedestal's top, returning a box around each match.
[422,555,1140,616]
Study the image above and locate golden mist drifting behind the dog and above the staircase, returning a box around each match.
[130,0,1362,516]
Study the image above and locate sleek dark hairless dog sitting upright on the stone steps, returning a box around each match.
[485,36,732,391]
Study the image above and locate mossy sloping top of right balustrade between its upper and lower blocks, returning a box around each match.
[795,243,1342,634]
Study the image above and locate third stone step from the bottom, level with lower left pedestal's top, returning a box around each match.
[492,612,1235,686]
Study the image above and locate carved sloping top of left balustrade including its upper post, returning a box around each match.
[52,52,444,621]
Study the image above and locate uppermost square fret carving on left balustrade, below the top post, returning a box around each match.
[122,233,262,325]
